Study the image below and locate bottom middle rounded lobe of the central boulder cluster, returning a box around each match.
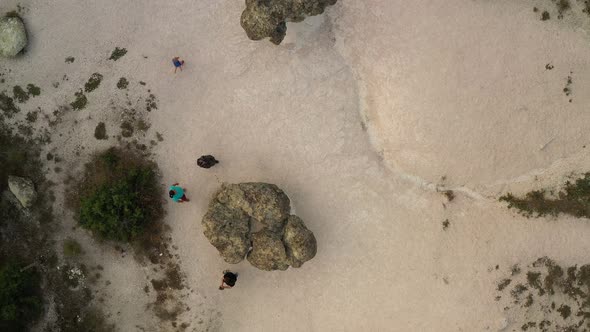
[248,229,289,271]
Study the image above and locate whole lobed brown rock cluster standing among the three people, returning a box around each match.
[202,183,317,271]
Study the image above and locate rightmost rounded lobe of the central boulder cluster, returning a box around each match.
[283,215,317,267]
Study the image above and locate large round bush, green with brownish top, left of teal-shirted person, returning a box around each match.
[74,148,163,242]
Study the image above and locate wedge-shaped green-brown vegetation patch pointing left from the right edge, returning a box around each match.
[500,173,590,218]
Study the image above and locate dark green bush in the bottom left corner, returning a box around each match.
[0,262,43,331]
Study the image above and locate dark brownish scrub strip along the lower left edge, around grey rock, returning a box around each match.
[0,119,114,332]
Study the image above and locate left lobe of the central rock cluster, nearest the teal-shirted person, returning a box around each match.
[202,200,250,264]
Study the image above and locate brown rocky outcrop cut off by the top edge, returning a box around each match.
[240,0,337,45]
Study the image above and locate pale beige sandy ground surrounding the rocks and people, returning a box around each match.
[0,0,590,331]
